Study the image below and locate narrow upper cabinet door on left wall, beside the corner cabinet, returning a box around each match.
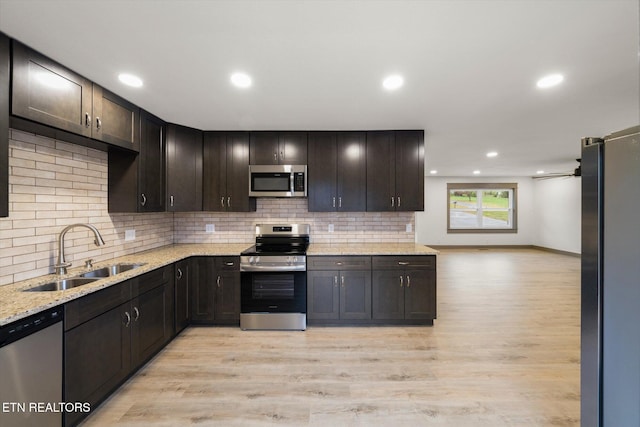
[136,110,166,212]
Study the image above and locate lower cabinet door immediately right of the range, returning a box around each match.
[307,271,340,320]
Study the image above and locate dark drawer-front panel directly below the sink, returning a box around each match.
[64,279,131,331]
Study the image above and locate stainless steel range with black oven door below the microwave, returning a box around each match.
[240,224,311,330]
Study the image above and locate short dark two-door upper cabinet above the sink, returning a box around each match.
[11,40,140,151]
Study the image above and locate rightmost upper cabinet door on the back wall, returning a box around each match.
[395,130,424,212]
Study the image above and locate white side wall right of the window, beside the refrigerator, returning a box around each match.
[532,178,582,253]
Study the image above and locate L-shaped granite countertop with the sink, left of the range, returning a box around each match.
[0,243,251,326]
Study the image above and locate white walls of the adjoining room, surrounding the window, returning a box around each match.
[415,177,581,253]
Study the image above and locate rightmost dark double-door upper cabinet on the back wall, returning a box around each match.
[367,130,424,212]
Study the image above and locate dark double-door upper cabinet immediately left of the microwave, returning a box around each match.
[202,132,256,212]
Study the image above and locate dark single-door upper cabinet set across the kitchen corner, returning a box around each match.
[166,124,202,212]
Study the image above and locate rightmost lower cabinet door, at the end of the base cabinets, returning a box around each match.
[404,270,436,319]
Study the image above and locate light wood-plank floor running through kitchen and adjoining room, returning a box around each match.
[84,249,580,427]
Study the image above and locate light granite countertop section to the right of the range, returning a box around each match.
[307,243,438,256]
